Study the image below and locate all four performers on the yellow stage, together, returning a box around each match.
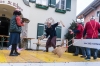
[9,9,100,60]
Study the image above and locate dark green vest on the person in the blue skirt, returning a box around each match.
[9,15,22,33]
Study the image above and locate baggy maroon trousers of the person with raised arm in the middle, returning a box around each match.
[46,36,56,52]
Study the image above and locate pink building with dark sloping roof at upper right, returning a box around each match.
[77,0,100,23]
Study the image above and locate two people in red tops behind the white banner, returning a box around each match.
[70,16,100,60]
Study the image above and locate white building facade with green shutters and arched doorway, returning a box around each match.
[0,0,77,49]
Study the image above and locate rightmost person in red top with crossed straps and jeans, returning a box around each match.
[83,17,100,60]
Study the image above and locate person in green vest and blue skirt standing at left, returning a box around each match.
[9,9,24,56]
